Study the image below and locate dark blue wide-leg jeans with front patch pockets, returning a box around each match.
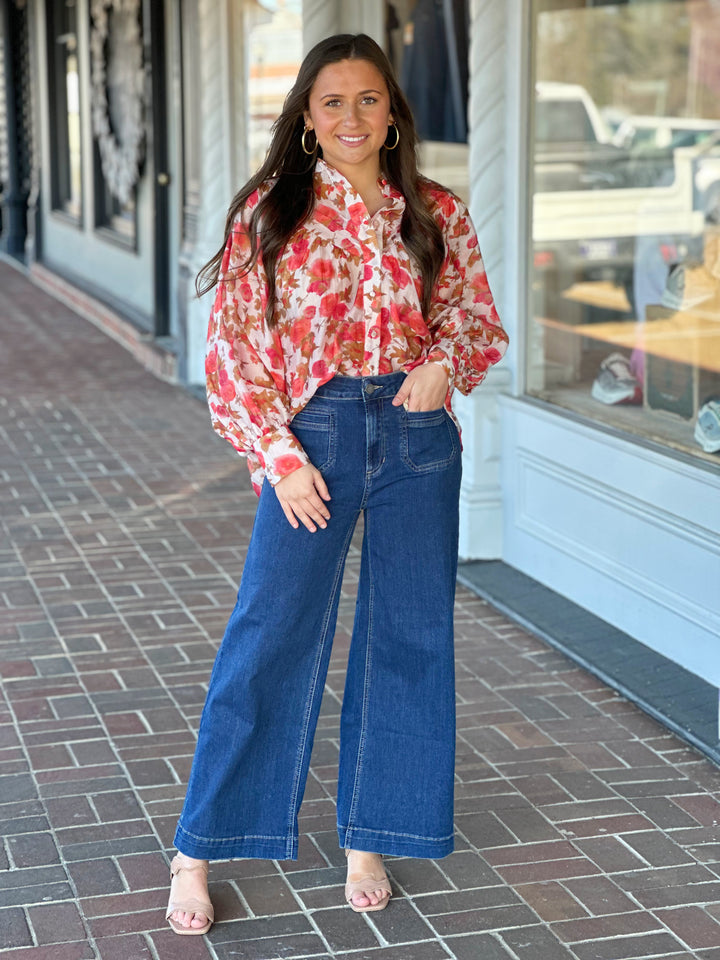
[175,373,461,860]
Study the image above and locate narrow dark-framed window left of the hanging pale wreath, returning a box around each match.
[47,0,82,221]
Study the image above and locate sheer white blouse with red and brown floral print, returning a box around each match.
[206,160,507,493]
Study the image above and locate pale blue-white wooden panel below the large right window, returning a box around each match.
[501,398,720,686]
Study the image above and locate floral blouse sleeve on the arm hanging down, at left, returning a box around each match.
[205,192,309,492]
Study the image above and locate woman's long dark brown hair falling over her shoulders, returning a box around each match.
[195,33,445,327]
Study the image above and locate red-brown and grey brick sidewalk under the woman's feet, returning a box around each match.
[0,263,720,960]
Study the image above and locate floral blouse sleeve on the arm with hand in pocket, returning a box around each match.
[427,190,508,394]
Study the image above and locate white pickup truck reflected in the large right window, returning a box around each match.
[533,83,704,323]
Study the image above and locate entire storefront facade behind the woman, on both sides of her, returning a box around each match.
[0,0,720,744]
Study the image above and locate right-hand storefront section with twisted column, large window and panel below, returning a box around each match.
[470,0,720,742]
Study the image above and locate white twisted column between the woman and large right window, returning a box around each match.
[453,0,527,560]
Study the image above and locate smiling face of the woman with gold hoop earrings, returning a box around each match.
[305,60,393,182]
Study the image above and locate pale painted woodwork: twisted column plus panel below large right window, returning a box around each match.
[470,0,720,686]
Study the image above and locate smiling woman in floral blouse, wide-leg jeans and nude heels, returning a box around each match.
[167,34,507,934]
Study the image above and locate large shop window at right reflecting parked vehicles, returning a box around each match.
[527,0,720,463]
